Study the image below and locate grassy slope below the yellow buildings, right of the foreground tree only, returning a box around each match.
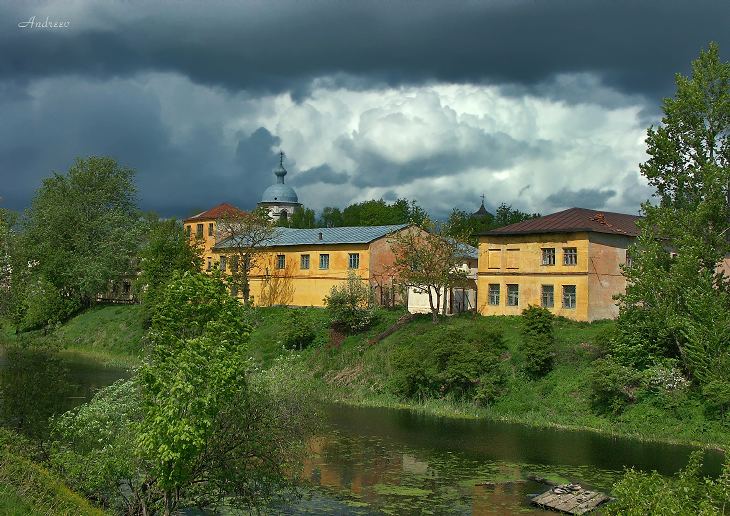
[251,308,730,446]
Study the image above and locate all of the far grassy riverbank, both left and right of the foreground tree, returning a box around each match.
[5,305,730,447]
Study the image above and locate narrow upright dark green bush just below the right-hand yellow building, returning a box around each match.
[520,306,555,378]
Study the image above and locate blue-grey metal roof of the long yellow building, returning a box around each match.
[215,224,408,249]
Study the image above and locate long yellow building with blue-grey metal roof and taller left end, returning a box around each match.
[184,204,408,306]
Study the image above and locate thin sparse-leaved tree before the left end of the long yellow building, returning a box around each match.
[216,207,276,306]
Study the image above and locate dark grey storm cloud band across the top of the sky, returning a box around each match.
[0,0,730,98]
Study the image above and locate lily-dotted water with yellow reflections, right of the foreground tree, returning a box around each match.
[278,406,722,515]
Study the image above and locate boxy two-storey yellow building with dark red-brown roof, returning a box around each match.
[477,208,639,321]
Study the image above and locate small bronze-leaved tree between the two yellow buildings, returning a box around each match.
[389,221,469,324]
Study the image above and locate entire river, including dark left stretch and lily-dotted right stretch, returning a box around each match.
[0,346,722,514]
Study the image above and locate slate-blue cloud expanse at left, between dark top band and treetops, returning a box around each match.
[0,74,278,217]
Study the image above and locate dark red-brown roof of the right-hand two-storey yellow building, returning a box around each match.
[480,208,641,236]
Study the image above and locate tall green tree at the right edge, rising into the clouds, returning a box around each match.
[614,44,730,403]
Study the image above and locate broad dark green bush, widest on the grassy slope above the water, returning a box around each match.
[390,326,506,404]
